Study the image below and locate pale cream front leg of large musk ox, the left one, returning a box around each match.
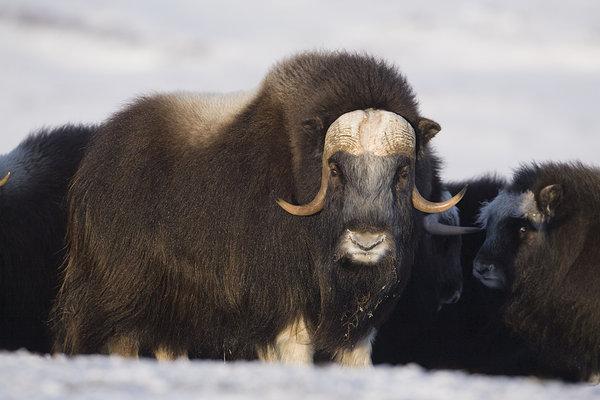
[257,318,314,364]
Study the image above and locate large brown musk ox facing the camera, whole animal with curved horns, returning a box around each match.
[54,53,461,365]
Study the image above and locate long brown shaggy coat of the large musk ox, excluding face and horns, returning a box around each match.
[54,53,436,359]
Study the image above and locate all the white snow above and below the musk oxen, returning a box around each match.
[0,0,600,400]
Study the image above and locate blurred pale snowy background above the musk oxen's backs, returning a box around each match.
[0,0,600,179]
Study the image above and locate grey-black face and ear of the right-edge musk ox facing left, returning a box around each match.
[473,185,562,289]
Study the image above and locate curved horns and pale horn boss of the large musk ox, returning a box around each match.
[277,109,469,235]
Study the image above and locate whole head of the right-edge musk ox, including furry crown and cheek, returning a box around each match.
[473,163,597,289]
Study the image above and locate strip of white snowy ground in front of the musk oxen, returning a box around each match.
[0,353,600,400]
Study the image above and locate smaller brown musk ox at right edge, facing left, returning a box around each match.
[474,163,600,379]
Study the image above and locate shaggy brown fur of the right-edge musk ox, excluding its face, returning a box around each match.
[504,163,600,378]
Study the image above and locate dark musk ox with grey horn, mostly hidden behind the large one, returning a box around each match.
[373,191,481,365]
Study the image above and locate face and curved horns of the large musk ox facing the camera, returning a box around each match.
[278,109,464,265]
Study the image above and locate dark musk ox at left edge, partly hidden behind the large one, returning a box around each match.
[0,126,93,353]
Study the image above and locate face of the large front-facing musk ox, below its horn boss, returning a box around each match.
[322,152,414,267]
